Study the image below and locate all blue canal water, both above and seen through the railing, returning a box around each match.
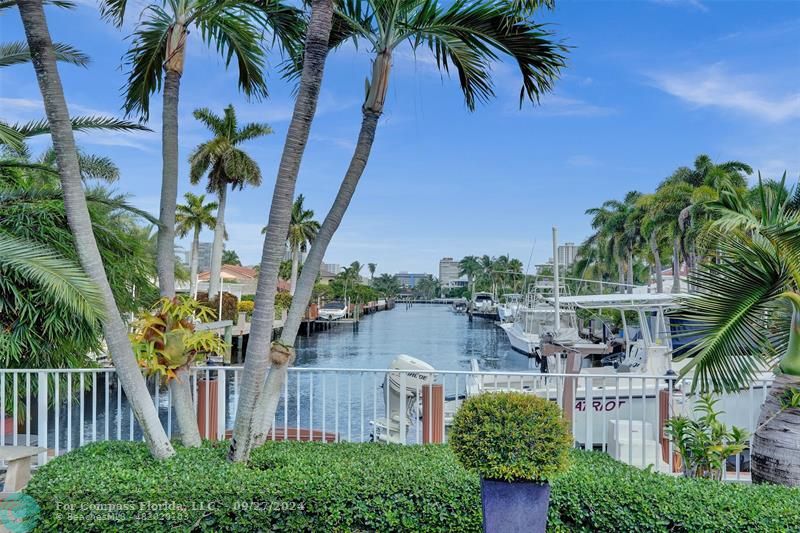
[31,304,528,452]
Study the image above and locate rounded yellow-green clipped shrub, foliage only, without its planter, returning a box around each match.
[448,392,572,481]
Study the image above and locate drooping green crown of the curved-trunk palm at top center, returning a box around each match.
[316,0,568,110]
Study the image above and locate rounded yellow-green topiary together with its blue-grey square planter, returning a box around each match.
[448,392,572,533]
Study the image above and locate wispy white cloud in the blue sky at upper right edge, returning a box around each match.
[650,63,800,122]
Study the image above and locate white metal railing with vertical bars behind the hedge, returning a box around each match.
[0,366,771,480]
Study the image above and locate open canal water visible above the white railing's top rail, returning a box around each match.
[295,304,528,370]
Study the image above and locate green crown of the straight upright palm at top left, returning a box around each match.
[115,0,305,120]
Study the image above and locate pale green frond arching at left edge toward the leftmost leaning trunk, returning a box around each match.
[0,232,104,321]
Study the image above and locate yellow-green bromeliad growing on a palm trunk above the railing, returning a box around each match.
[131,296,227,382]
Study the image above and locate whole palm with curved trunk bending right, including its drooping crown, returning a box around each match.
[251,0,567,448]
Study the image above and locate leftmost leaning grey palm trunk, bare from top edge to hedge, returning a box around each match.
[17,0,175,459]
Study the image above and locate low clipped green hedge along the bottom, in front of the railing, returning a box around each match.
[21,442,800,532]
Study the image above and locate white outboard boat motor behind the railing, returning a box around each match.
[371,355,436,444]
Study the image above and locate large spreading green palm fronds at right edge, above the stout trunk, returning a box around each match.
[678,179,800,390]
